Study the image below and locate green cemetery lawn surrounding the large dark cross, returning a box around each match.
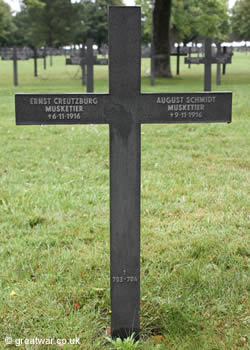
[0,53,250,350]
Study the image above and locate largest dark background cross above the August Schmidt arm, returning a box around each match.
[185,38,232,91]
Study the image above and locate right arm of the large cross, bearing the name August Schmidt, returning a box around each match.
[137,92,232,123]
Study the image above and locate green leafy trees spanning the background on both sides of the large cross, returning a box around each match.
[0,0,250,47]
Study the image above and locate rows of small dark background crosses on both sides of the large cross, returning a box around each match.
[0,39,233,92]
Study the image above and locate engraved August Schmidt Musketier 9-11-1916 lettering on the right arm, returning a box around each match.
[156,96,216,119]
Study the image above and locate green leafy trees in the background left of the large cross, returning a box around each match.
[0,0,123,48]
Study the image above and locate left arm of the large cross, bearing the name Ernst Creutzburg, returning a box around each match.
[15,94,109,125]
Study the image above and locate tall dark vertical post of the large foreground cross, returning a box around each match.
[109,7,141,338]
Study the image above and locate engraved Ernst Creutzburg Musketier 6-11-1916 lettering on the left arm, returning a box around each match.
[29,97,98,120]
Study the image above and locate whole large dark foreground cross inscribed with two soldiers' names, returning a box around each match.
[16,6,232,339]
